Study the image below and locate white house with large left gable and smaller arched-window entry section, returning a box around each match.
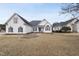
[5,13,52,34]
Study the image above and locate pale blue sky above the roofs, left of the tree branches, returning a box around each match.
[0,3,71,24]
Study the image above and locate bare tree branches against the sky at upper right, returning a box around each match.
[61,3,79,18]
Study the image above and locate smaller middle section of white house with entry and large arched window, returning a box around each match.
[30,19,52,33]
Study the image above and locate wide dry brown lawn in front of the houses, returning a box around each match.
[0,33,79,56]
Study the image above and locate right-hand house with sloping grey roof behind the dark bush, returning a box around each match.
[53,18,78,32]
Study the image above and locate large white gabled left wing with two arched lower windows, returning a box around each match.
[5,13,33,34]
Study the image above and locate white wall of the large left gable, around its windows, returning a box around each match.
[6,15,33,34]
